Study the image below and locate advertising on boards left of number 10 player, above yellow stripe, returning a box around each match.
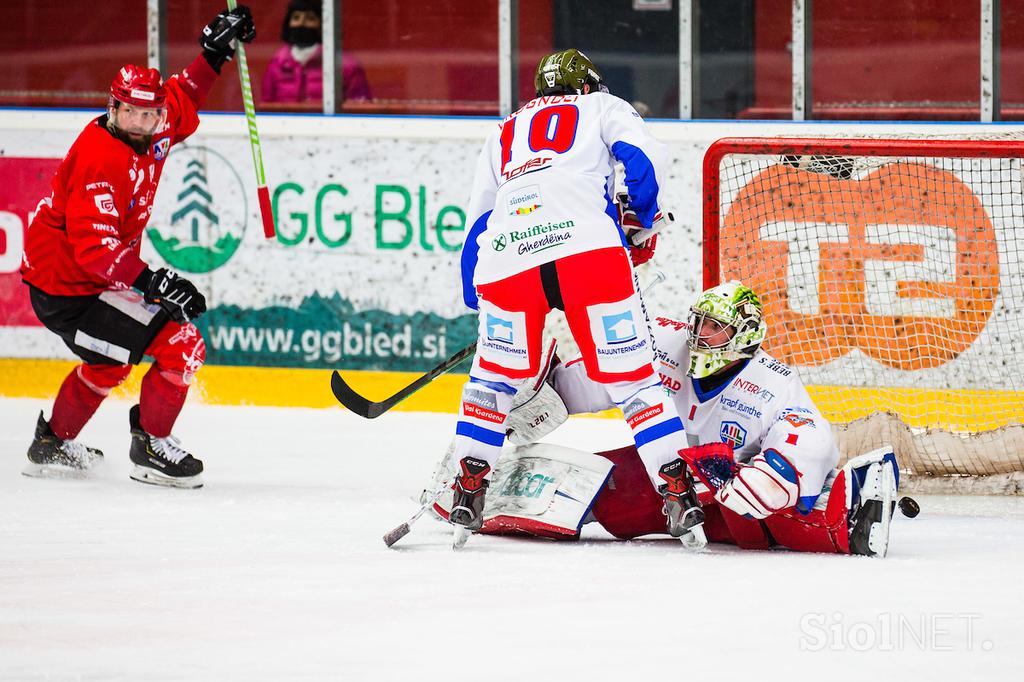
[0,120,491,372]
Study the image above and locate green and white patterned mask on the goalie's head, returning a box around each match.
[686,282,767,379]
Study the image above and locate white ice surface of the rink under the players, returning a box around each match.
[0,398,1024,682]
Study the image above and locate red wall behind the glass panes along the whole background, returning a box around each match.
[6,0,1024,115]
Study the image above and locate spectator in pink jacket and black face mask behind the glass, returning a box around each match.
[260,0,370,102]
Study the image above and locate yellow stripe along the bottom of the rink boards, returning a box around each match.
[0,358,1024,432]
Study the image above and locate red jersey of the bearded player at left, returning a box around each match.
[22,55,217,296]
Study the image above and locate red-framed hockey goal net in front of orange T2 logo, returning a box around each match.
[703,138,1024,493]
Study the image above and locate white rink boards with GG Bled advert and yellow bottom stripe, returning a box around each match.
[0,110,1024,429]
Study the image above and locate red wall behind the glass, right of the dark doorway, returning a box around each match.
[755,0,1024,113]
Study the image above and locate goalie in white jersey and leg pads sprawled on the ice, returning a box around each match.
[434,282,898,556]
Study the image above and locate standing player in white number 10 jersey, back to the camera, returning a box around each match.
[450,49,700,546]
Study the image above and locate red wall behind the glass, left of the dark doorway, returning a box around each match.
[0,0,552,113]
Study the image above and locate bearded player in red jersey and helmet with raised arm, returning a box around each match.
[22,5,256,487]
